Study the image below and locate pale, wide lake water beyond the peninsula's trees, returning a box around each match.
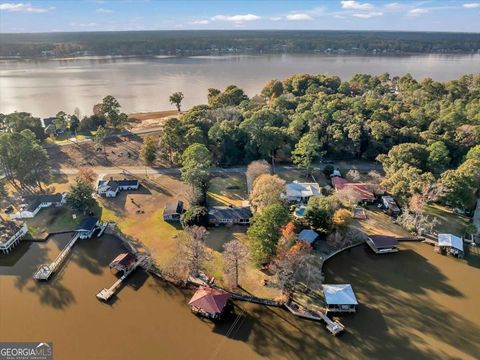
[0,54,480,117]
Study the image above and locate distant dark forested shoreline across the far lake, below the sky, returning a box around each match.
[0,30,480,57]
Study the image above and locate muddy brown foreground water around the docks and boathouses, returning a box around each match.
[0,235,480,360]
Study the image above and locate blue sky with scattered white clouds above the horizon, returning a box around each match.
[0,0,480,32]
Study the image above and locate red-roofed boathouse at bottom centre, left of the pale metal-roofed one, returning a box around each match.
[188,286,230,320]
